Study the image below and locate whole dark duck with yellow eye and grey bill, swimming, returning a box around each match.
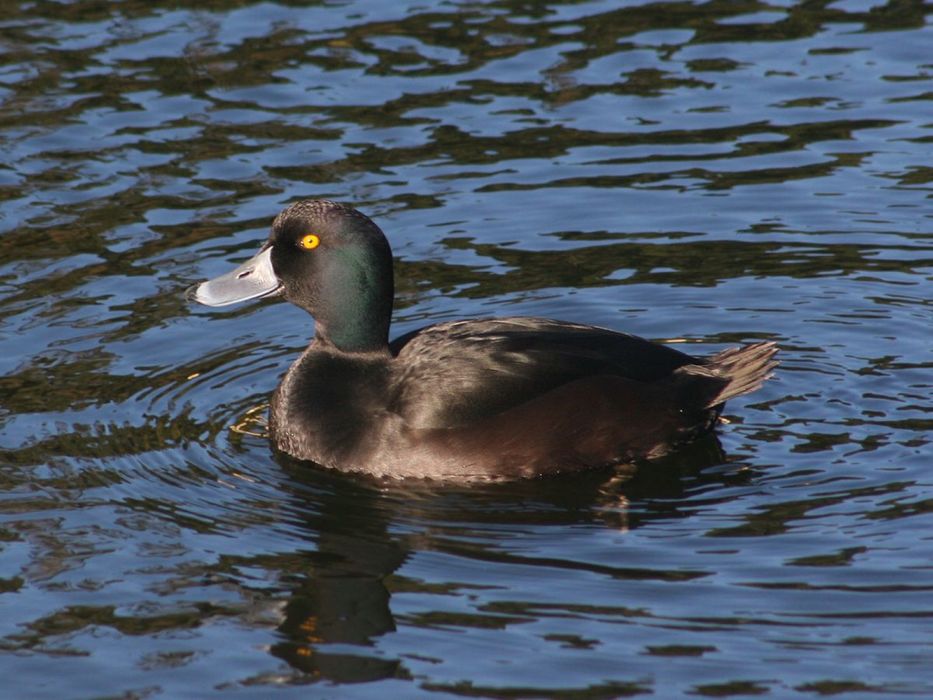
[188,199,778,481]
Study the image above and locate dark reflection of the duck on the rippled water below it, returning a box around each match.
[239,435,750,683]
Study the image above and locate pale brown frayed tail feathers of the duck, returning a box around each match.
[678,342,780,408]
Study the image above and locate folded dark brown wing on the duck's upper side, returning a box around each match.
[388,317,705,428]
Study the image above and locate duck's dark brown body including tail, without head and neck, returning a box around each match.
[270,317,776,481]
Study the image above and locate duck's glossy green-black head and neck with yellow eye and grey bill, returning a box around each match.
[189,200,394,352]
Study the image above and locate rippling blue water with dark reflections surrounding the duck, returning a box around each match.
[0,0,933,698]
